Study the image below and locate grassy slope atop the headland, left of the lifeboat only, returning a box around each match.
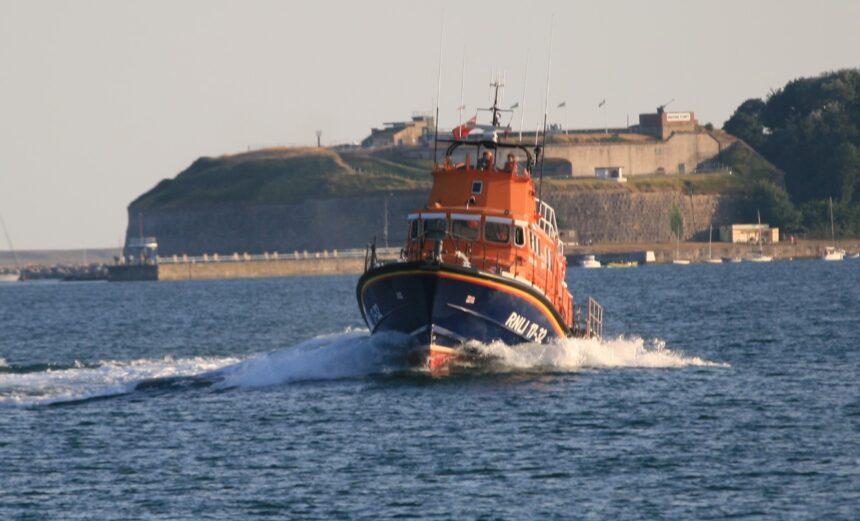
[131,148,430,208]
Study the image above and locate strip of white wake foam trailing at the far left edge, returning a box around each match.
[0,357,238,407]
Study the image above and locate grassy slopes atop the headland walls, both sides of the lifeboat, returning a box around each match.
[132,139,782,209]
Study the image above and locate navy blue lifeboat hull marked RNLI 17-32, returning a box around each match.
[356,263,570,354]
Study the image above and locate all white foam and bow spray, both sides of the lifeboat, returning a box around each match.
[0,330,728,407]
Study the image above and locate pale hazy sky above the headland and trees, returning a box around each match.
[0,0,860,250]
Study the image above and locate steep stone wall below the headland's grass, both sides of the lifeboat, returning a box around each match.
[126,190,745,256]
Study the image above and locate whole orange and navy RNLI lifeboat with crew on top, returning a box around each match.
[356,83,603,372]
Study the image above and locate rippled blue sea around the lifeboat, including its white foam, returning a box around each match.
[0,260,860,520]
